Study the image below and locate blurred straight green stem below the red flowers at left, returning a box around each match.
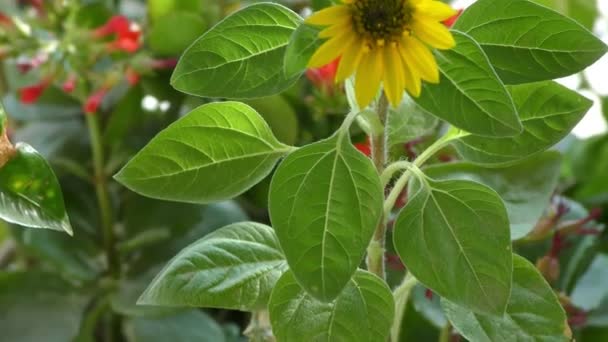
[86,114,120,278]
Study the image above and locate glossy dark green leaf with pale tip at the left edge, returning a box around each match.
[0,143,73,235]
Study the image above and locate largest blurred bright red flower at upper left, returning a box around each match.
[93,15,141,53]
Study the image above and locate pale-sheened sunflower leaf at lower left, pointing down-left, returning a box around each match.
[138,222,286,311]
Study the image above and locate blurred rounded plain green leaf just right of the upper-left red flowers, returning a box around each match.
[148,12,205,56]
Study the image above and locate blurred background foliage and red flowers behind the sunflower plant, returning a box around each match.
[0,0,608,342]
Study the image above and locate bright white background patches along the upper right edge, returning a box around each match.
[452,0,608,138]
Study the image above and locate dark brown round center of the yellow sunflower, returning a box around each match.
[351,0,412,42]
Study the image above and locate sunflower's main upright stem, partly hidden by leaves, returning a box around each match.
[367,92,389,279]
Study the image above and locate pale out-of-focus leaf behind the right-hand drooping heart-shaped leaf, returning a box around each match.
[424,152,561,240]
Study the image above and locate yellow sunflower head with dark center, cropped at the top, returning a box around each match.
[306,0,457,107]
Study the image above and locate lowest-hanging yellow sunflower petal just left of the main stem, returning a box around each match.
[355,50,383,108]
